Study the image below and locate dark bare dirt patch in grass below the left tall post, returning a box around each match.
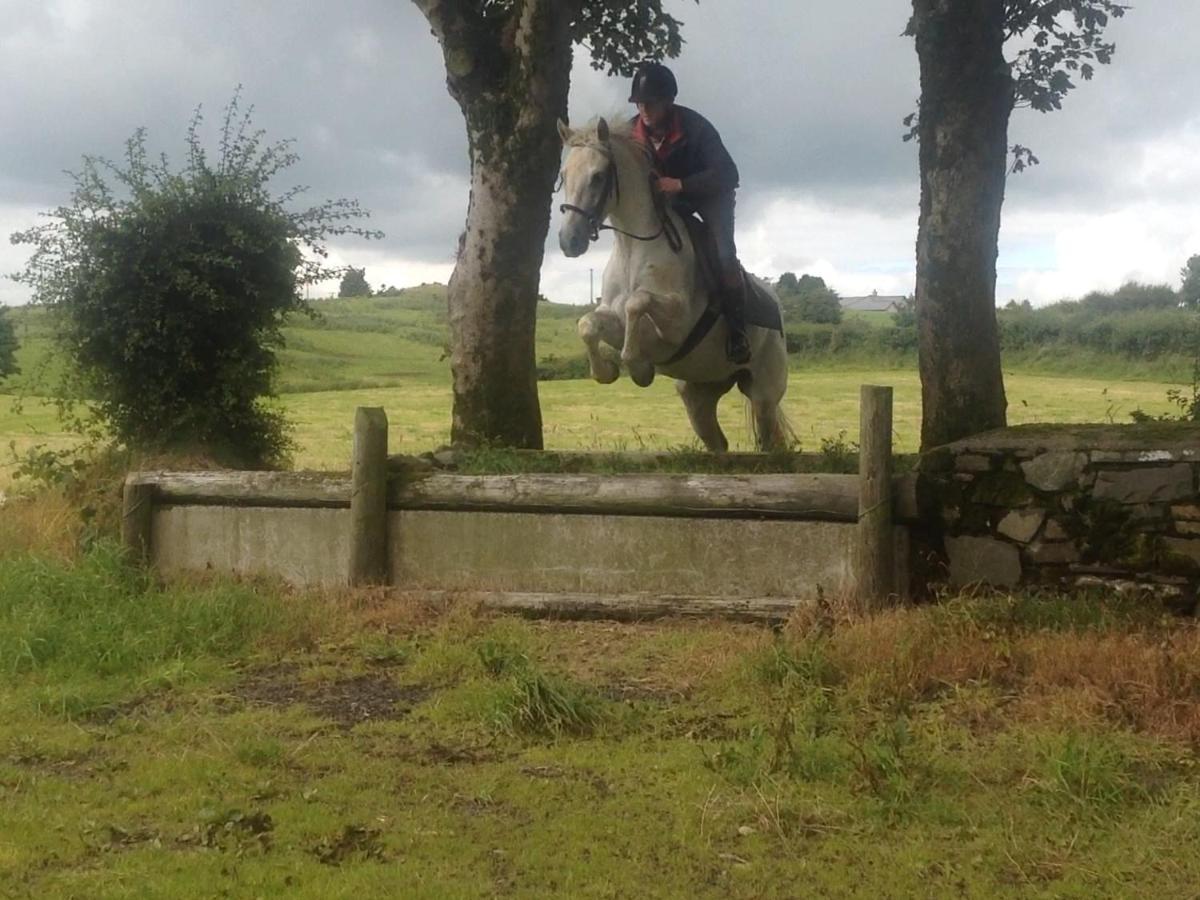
[233,664,433,728]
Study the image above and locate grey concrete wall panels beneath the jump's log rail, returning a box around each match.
[151,505,908,600]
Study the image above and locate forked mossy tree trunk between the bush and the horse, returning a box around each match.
[414,0,574,448]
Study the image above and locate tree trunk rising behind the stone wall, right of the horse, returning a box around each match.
[913,0,1013,450]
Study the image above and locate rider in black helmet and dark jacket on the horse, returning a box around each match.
[629,62,750,365]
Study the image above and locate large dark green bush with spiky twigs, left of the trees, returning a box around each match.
[13,95,377,466]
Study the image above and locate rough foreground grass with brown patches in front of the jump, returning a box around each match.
[0,554,1200,898]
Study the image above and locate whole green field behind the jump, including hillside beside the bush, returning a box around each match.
[0,286,1177,485]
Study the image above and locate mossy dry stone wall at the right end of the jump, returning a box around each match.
[920,422,1200,607]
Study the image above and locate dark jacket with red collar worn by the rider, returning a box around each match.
[632,106,738,200]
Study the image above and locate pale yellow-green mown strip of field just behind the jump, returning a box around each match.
[283,368,1171,468]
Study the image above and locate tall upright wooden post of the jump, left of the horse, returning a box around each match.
[349,407,388,586]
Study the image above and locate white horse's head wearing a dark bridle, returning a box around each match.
[558,119,617,257]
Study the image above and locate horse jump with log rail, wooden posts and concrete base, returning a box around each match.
[122,385,913,619]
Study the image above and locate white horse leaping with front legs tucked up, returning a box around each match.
[558,119,791,452]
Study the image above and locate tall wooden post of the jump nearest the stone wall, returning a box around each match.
[856,384,895,607]
